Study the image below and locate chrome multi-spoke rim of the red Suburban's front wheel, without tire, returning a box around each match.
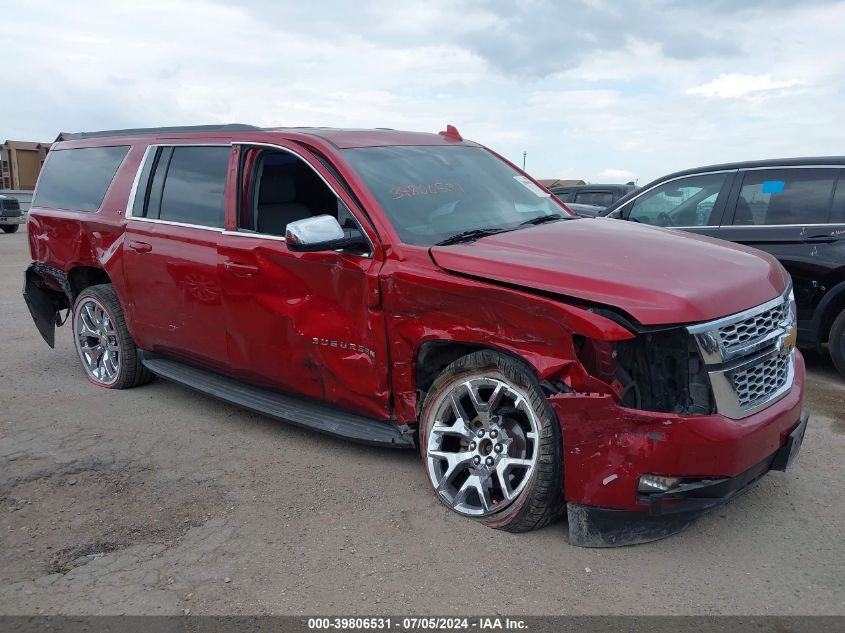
[426,377,539,517]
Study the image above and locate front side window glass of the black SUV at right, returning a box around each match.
[627,173,728,227]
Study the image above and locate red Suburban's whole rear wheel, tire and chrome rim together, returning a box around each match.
[73,284,152,389]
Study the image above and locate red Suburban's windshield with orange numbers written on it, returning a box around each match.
[343,145,570,246]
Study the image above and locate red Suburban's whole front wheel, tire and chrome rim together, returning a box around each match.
[420,350,563,532]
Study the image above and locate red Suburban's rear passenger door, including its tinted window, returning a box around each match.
[123,144,232,370]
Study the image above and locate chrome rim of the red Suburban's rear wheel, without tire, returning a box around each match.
[73,297,120,385]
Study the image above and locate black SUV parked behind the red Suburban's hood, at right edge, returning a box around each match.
[599,157,845,376]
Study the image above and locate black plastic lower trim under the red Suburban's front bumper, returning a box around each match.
[566,414,809,547]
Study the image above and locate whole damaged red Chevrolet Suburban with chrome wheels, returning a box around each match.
[24,125,807,546]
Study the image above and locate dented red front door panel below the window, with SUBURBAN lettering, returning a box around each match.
[219,233,390,419]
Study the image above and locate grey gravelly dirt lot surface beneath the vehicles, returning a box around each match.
[0,232,845,615]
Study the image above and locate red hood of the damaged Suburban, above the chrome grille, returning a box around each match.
[431,219,787,325]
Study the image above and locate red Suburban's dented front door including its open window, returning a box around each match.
[219,145,390,419]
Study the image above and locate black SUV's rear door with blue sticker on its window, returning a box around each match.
[722,167,845,321]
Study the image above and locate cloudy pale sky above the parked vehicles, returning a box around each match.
[0,0,845,184]
